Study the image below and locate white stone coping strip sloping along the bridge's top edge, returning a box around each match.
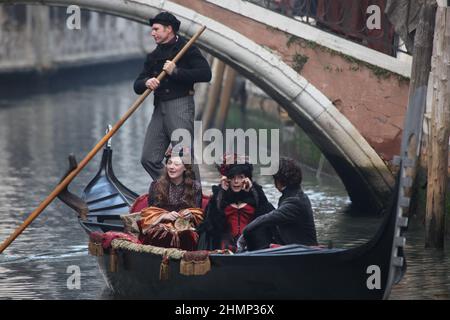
[206,0,412,78]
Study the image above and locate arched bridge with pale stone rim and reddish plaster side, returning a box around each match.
[0,0,410,208]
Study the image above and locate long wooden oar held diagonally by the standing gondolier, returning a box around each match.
[0,26,206,253]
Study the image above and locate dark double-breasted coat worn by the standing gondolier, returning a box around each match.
[134,35,211,104]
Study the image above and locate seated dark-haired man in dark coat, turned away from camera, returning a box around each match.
[238,158,317,248]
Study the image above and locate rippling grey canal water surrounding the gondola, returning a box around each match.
[0,64,450,299]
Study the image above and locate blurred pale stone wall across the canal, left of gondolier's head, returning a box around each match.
[0,5,151,73]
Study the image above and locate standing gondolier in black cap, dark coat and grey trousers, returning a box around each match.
[134,12,211,180]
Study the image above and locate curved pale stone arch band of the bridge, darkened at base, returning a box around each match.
[0,0,394,209]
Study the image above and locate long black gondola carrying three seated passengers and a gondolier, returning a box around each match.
[59,136,406,299]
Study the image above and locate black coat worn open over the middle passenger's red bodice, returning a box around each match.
[197,182,275,250]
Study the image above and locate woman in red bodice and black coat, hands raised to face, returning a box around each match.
[198,155,274,252]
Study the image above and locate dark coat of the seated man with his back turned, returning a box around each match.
[243,187,317,246]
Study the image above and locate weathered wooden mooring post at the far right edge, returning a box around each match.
[425,0,450,248]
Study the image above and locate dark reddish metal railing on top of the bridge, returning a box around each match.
[246,0,407,57]
